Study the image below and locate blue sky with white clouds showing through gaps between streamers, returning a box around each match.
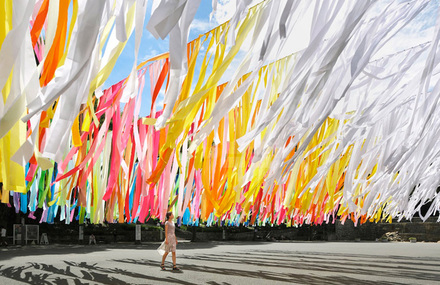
[104,0,439,117]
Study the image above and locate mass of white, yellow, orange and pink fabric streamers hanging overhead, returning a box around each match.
[0,0,440,226]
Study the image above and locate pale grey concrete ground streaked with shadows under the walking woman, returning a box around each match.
[0,242,440,285]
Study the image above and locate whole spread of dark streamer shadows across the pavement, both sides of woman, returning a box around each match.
[0,247,440,285]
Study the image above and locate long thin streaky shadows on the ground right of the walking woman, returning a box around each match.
[181,250,440,284]
